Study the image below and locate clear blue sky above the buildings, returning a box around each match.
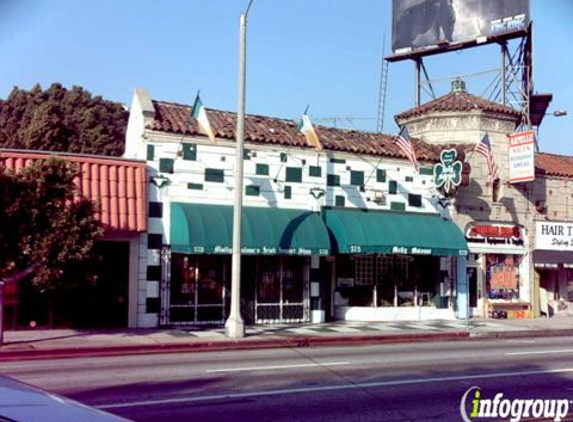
[0,0,573,155]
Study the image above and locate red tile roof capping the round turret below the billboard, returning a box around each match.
[394,91,521,123]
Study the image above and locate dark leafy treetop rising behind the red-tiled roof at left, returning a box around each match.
[0,84,129,156]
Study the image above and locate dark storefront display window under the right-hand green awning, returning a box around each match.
[335,254,440,307]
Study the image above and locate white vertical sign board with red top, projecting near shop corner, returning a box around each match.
[509,130,535,183]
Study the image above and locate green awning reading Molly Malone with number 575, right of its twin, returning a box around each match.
[324,209,468,256]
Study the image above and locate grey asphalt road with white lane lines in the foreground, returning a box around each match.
[0,338,573,422]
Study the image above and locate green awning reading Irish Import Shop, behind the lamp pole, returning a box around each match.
[170,203,330,255]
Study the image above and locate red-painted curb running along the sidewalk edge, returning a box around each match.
[0,331,470,362]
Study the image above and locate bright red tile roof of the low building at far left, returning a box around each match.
[0,150,147,232]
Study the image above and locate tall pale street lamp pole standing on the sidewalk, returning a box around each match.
[225,0,253,339]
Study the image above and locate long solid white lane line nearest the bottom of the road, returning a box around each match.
[97,368,573,409]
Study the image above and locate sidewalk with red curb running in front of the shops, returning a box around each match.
[0,317,573,361]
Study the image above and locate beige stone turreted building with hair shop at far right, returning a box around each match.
[396,83,573,317]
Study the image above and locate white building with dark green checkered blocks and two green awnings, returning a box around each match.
[126,89,467,326]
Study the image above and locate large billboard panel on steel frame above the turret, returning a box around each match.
[392,0,530,54]
